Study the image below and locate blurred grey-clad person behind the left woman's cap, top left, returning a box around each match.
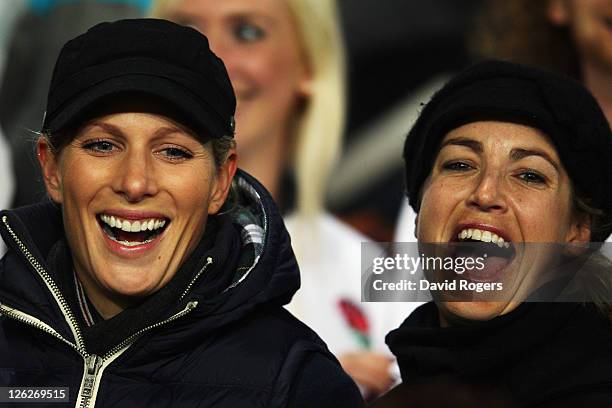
[0,0,149,207]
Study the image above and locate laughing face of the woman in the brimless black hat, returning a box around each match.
[416,121,590,320]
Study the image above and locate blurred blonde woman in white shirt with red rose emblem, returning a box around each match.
[152,0,391,393]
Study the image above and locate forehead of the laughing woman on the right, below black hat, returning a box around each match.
[441,121,559,161]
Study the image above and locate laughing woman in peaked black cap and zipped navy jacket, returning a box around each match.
[0,20,361,407]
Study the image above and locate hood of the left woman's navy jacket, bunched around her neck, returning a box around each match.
[0,170,300,350]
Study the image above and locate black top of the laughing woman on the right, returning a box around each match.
[373,303,612,408]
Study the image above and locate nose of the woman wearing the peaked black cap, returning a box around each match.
[113,151,158,203]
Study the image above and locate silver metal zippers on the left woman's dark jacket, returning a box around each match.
[0,215,198,408]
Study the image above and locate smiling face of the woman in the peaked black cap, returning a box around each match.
[38,112,236,317]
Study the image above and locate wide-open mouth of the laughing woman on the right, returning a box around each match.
[452,228,516,282]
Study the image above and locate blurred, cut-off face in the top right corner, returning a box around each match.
[549,0,612,72]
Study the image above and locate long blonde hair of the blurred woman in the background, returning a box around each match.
[152,0,345,216]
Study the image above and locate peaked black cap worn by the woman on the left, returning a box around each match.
[42,19,236,138]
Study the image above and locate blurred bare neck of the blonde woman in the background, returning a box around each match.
[238,127,287,202]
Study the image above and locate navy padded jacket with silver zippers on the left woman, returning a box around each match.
[0,173,362,407]
